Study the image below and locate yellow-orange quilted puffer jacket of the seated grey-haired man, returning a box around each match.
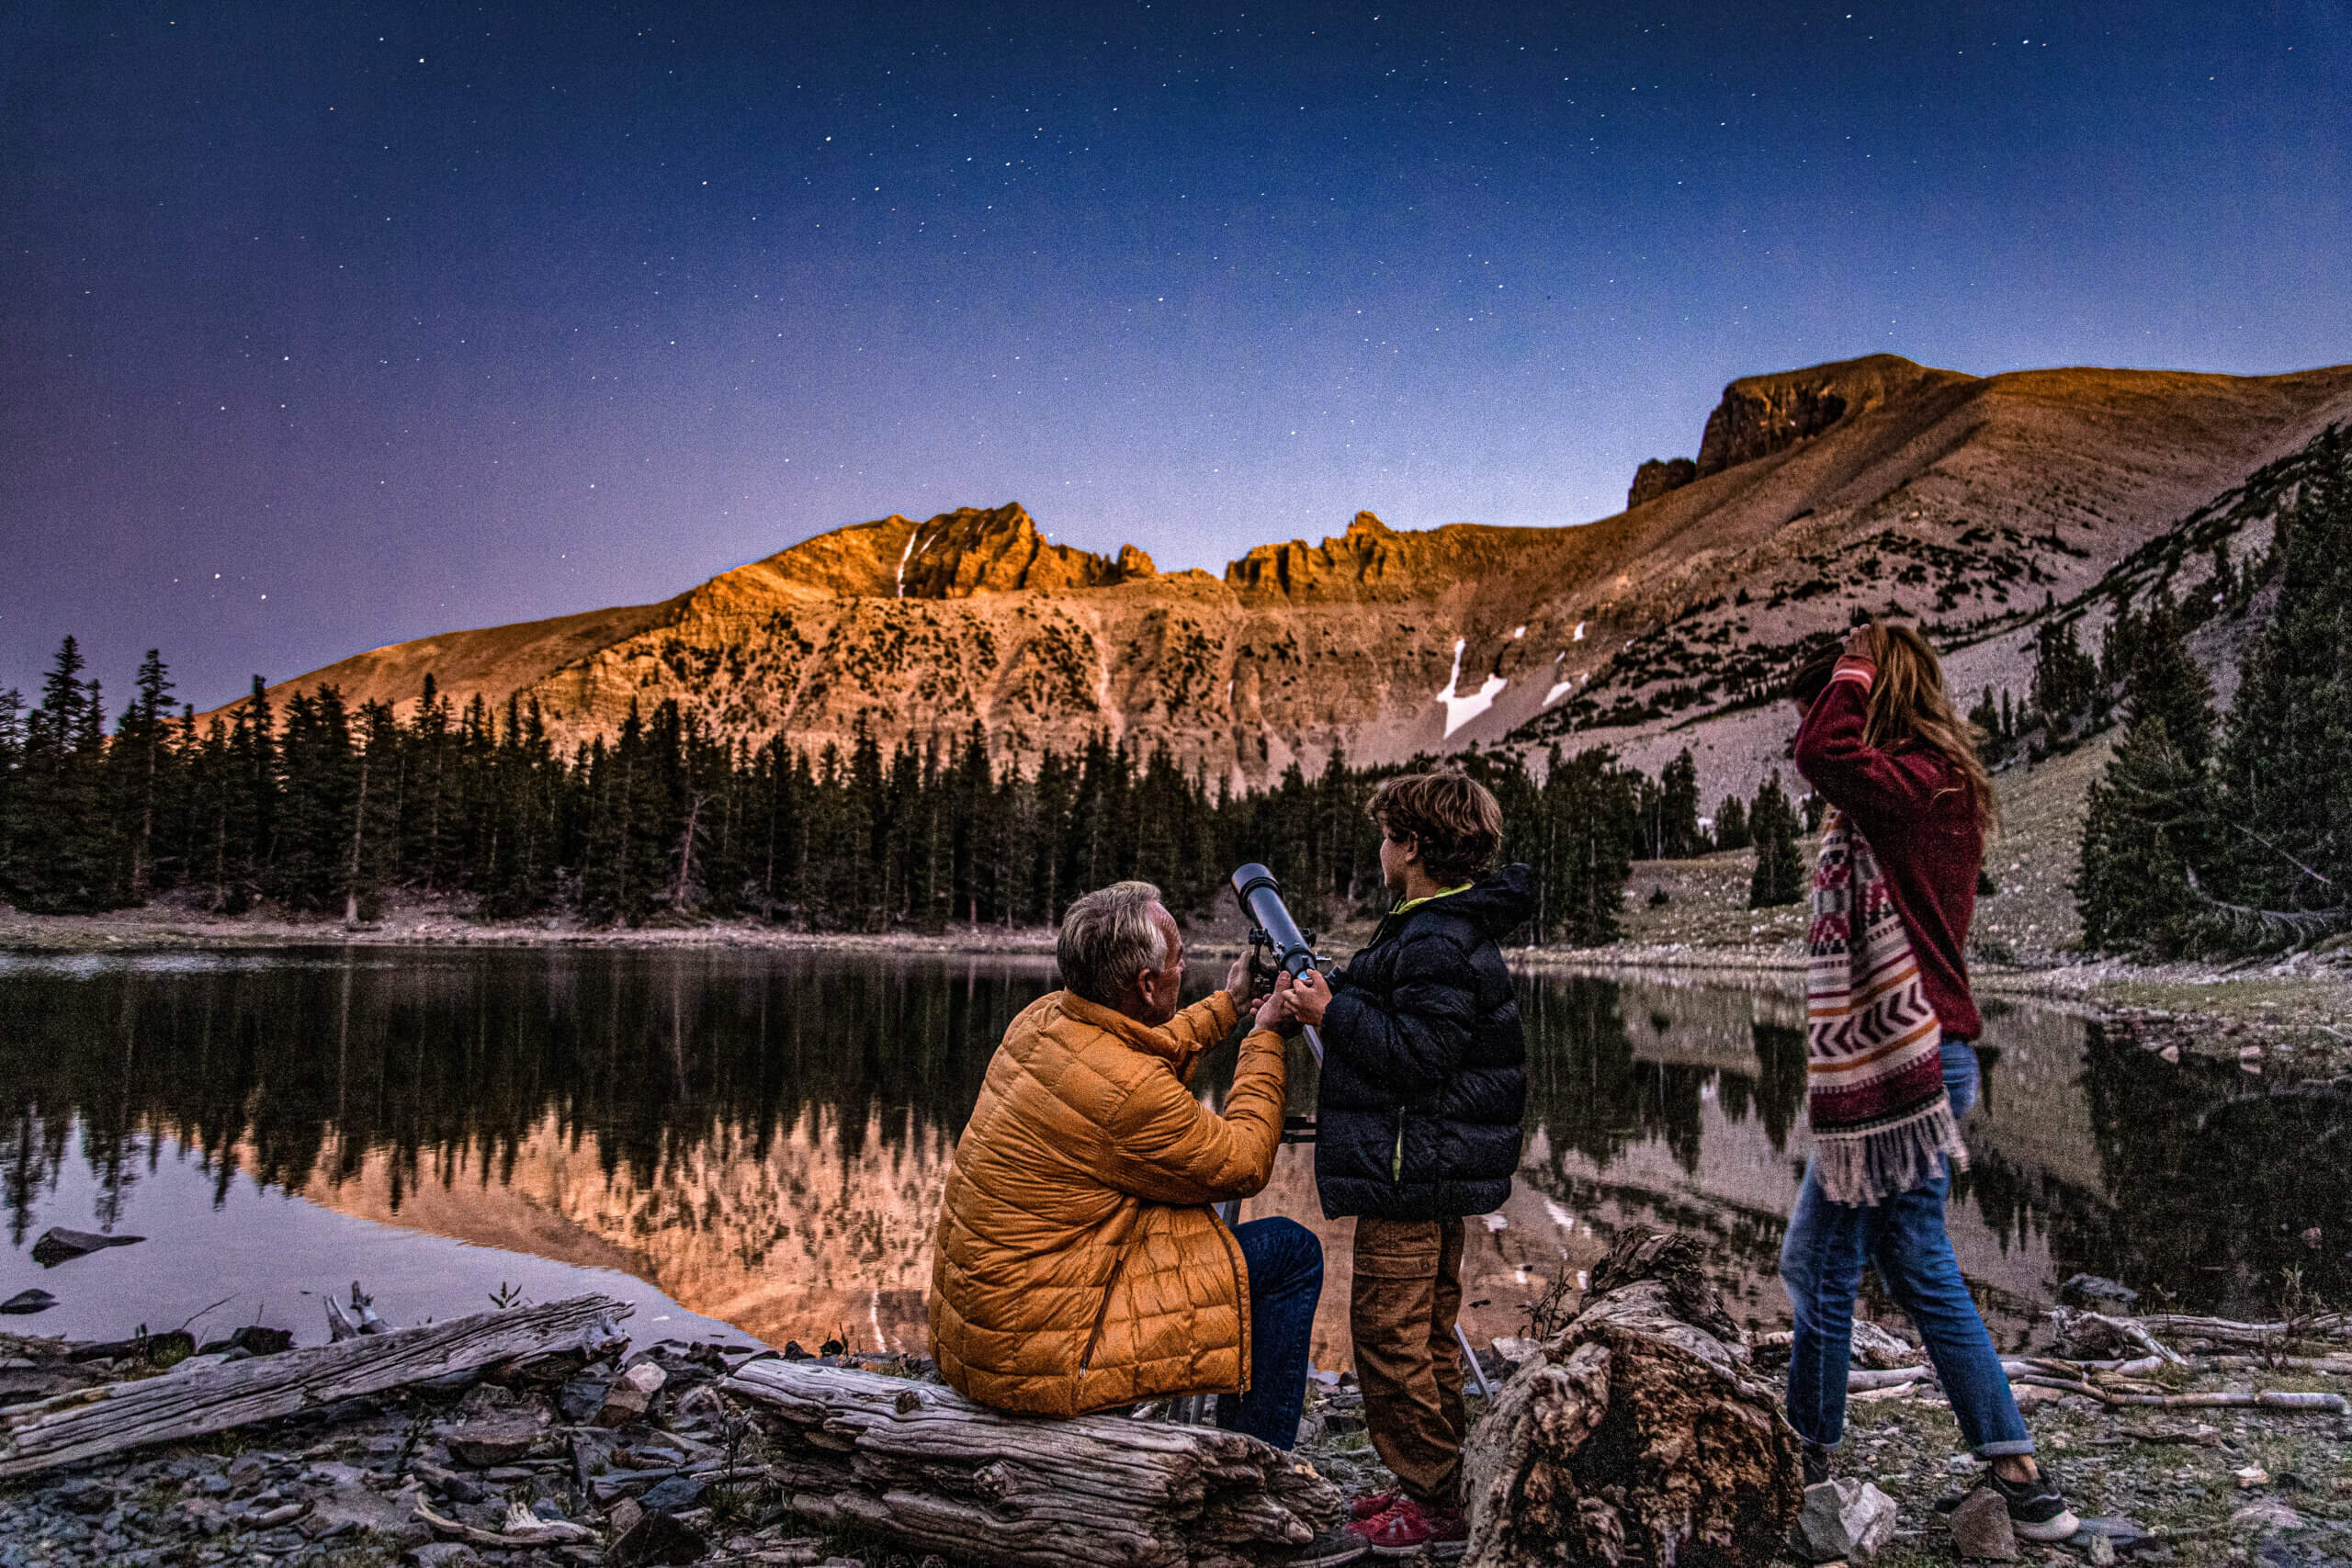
[932,992,1282,1416]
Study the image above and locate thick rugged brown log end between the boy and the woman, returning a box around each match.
[1463,1232,1804,1568]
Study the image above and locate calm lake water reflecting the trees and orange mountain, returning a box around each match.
[0,950,2352,1366]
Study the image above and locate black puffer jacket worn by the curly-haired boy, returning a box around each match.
[1315,865,1533,1220]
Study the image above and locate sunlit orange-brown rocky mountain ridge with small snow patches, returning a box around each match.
[233,355,2352,799]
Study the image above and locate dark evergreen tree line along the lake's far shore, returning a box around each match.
[0,637,1844,945]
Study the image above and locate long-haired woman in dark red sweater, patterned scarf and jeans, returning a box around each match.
[1781,626,2079,1540]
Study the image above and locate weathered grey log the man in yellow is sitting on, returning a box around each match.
[719,1361,1340,1568]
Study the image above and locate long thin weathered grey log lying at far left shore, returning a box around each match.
[0,1295,630,1476]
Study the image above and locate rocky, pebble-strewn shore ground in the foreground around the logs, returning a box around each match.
[0,1281,2352,1568]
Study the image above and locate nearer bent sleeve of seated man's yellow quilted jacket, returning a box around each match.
[1105,1030,1284,1206]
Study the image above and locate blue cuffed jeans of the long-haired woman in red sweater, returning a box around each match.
[1781,1034,2034,1460]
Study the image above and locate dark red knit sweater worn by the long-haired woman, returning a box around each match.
[1797,656,1985,1039]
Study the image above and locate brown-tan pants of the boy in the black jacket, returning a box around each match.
[1348,1215,1465,1506]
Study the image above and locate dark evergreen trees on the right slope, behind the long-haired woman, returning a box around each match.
[2075,433,2352,957]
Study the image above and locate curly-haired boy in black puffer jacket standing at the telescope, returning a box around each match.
[1289,773,1533,1556]
